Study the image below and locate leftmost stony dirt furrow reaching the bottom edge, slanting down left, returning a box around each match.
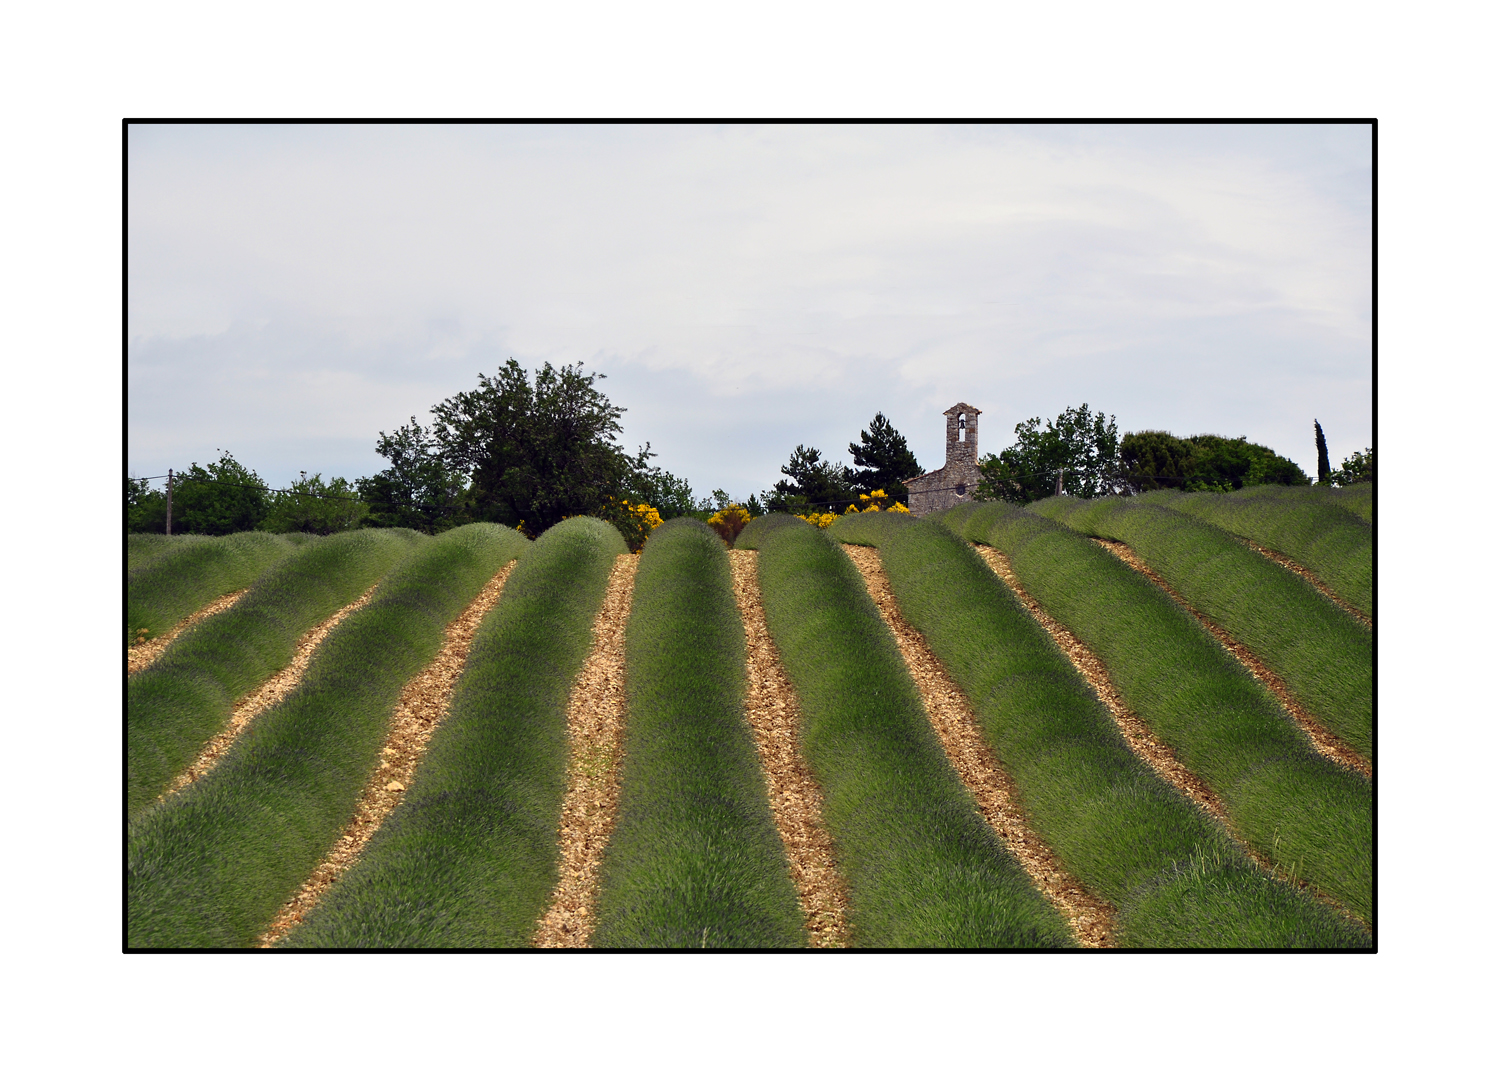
[260,561,516,948]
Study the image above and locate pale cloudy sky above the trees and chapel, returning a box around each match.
[126,125,1374,498]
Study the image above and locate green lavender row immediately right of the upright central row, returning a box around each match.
[756,513,1074,948]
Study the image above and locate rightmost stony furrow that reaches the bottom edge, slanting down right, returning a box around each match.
[845,543,1115,948]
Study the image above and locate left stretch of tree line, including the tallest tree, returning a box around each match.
[126,359,690,537]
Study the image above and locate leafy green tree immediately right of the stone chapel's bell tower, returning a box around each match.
[977,402,1121,503]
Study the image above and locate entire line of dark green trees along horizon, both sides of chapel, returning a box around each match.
[125,359,1374,546]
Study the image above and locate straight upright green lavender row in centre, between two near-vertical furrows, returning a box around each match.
[594,518,806,948]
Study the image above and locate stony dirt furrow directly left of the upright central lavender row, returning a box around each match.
[531,554,641,948]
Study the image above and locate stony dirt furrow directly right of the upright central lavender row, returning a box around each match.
[729,551,849,948]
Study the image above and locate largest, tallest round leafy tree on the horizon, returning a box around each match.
[432,359,653,533]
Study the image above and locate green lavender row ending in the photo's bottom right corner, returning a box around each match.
[831,504,1370,948]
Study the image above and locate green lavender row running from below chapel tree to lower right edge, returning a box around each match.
[962,503,1374,923]
